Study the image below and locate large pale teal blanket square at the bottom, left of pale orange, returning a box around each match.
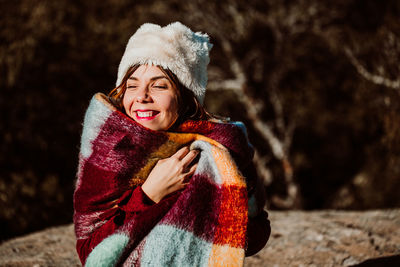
[140,225,212,267]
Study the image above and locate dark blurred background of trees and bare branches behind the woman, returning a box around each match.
[0,0,400,240]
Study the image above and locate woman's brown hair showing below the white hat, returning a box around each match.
[108,64,221,128]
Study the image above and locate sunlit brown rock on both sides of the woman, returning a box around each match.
[0,209,400,267]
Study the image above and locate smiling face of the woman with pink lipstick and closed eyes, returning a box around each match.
[122,65,178,131]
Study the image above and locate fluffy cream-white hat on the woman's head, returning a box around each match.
[116,22,212,103]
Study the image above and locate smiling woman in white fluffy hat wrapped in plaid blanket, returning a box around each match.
[74,22,270,266]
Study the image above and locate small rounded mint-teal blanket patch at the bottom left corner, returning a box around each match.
[85,234,129,267]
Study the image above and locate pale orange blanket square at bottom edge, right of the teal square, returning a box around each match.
[208,245,244,267]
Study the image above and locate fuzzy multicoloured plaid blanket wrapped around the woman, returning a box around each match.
[74,93,253,266]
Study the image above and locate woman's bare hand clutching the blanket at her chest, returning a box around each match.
[142,146,199,203]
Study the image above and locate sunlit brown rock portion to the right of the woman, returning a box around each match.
[246,210,400,267]
